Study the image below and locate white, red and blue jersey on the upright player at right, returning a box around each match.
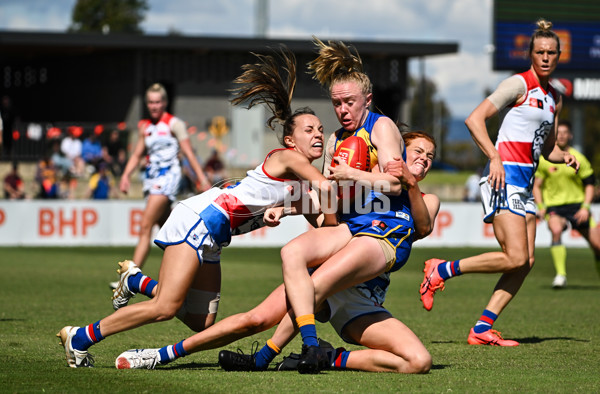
[492,70,558,190]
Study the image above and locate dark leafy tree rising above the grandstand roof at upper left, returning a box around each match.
[69,0,148,34]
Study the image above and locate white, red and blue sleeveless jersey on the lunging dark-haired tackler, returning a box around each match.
[181,149,300,246]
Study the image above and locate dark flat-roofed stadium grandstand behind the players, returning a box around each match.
[0,32,458,168]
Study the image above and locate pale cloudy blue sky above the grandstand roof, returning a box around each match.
[0,0,508,118]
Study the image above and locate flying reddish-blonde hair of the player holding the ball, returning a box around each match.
[308,36,373,95]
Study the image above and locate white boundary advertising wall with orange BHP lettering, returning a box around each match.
[0,200,600,247]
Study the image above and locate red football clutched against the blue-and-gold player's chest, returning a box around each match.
[331,135,371,198]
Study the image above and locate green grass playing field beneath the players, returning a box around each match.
[0,246,600,393]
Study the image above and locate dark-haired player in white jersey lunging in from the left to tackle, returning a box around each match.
[57,47,337,368]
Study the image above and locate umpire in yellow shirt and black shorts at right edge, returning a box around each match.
[533,121,600,288]
